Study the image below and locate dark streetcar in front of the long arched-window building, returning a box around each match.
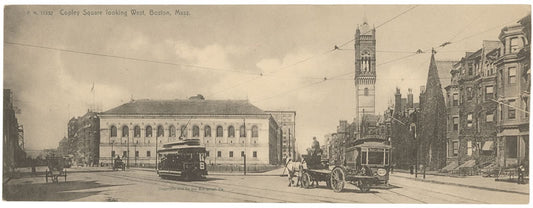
[157,139,207,181]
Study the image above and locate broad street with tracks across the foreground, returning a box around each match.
[4,169,529,204]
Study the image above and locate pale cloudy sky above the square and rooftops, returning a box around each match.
[4,5,530,150]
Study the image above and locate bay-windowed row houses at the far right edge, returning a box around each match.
[446,15,530,170]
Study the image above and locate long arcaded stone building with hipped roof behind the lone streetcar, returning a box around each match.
[100,96,280,166]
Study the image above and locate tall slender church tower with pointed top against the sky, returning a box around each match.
[355,18,376,123]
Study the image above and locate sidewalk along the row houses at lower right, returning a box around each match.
[391,170,529,195]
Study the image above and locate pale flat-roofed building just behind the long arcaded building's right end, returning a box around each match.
[265,111,296,161]
